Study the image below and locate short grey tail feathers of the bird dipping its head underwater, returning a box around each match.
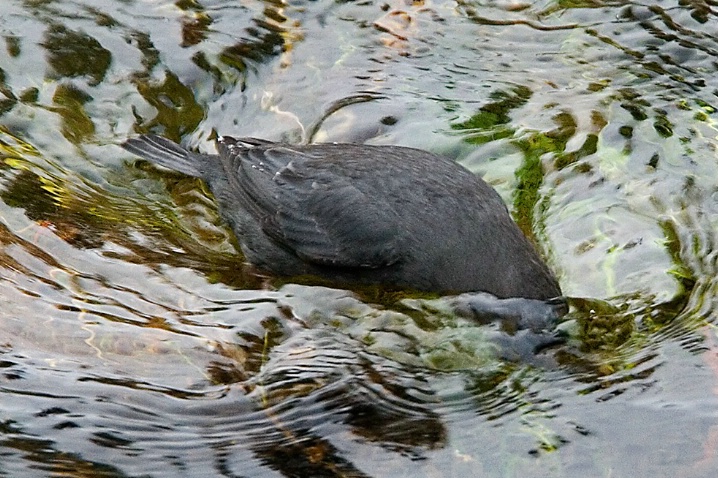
[122,134,210,178]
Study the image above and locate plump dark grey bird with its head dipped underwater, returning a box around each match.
[123,135,561,300]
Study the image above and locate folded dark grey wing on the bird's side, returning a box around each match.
[220,141,404,268]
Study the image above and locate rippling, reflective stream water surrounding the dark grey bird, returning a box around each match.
[0,0,718,477]
